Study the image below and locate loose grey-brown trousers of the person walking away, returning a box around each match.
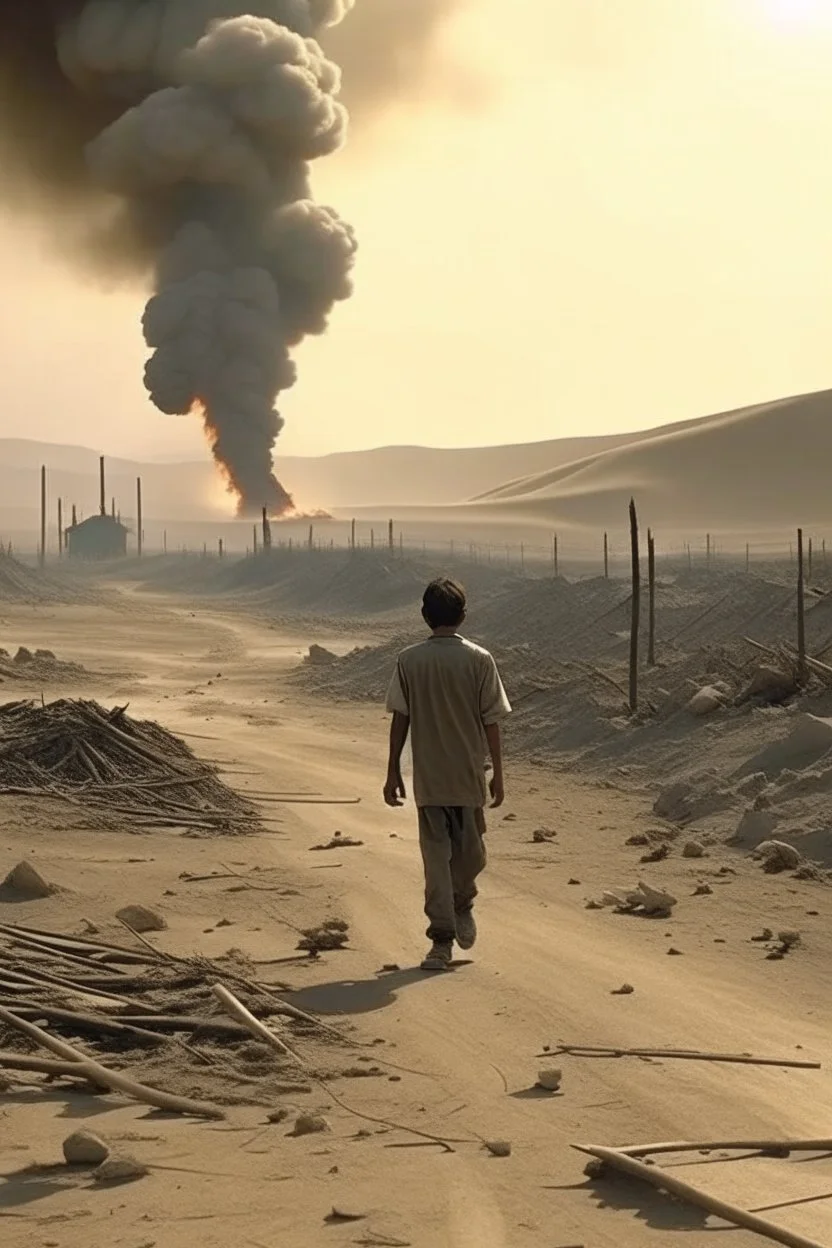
[419,806,486,941]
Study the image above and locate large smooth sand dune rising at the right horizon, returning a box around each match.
[470,391,832,532]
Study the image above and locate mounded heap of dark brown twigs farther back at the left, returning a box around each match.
[0,699,262,834]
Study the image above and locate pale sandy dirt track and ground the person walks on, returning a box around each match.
[0,592,832,1248]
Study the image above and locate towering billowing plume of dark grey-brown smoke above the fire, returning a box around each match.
[0,0,356,516]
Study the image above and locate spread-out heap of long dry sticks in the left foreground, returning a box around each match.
[0,925,351,1113]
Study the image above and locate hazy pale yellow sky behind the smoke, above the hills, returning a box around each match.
[0,0,832,456]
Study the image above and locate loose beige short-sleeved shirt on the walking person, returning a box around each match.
[387,635,511,807]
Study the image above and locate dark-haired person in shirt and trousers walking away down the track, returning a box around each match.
[384,578,511,971]
